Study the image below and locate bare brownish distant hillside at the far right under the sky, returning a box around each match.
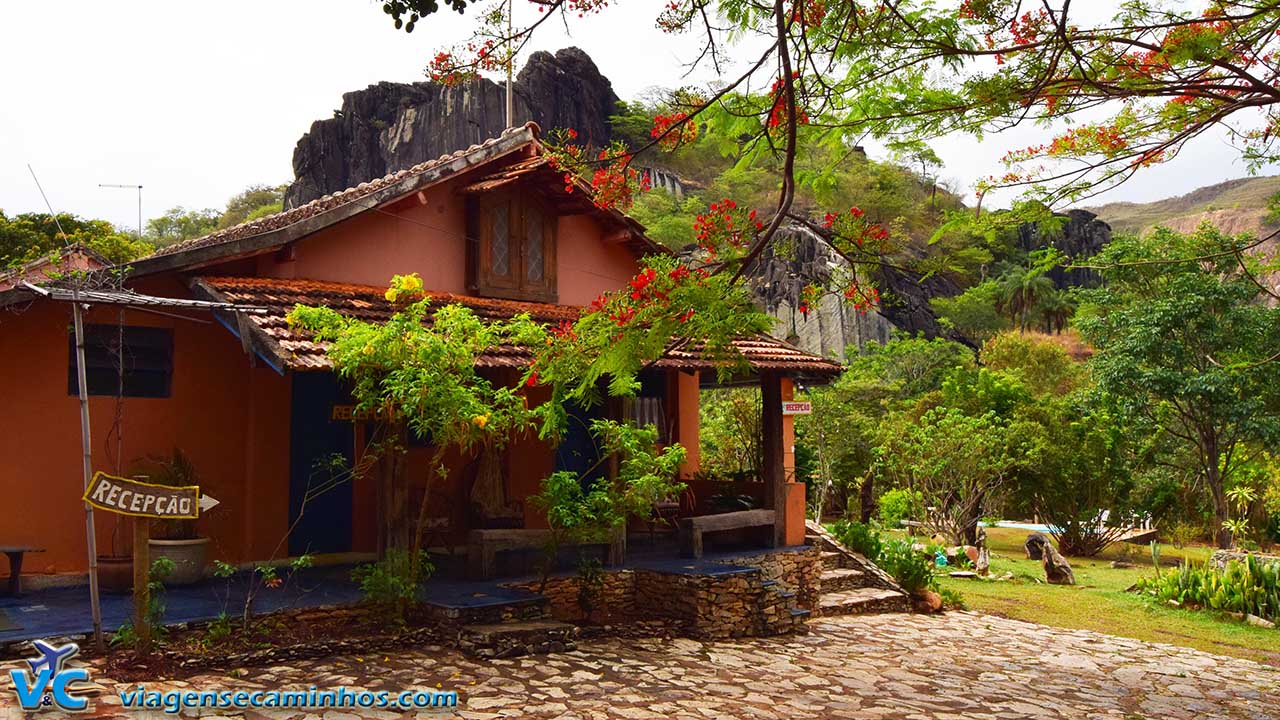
[1088,176,1280,233]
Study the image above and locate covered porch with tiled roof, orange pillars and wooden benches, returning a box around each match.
[192,277,842,579]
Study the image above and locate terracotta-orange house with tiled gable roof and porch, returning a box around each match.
[0,124,840,574]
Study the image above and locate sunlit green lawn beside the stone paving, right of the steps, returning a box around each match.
[901,528,1280,666]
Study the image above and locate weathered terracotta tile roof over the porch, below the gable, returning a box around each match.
[196,277,844,378]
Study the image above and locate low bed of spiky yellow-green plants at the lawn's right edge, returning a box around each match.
[1137,555,1280,621]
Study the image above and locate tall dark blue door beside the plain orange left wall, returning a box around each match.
[289,373,355,556]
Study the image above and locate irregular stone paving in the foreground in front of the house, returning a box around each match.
[0,612,1280,720]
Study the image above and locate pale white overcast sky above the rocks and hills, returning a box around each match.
[0,0,1269,228]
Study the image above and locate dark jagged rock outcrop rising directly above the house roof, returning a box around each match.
[284,47,618,208]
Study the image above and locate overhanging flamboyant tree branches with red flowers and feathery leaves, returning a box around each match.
[366,0,1280,307]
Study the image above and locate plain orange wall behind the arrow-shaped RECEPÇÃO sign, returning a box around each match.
[0,274,289,573]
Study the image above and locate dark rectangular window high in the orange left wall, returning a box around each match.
[67,325,173,397]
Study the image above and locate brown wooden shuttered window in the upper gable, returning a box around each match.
[467,195,557,302]
